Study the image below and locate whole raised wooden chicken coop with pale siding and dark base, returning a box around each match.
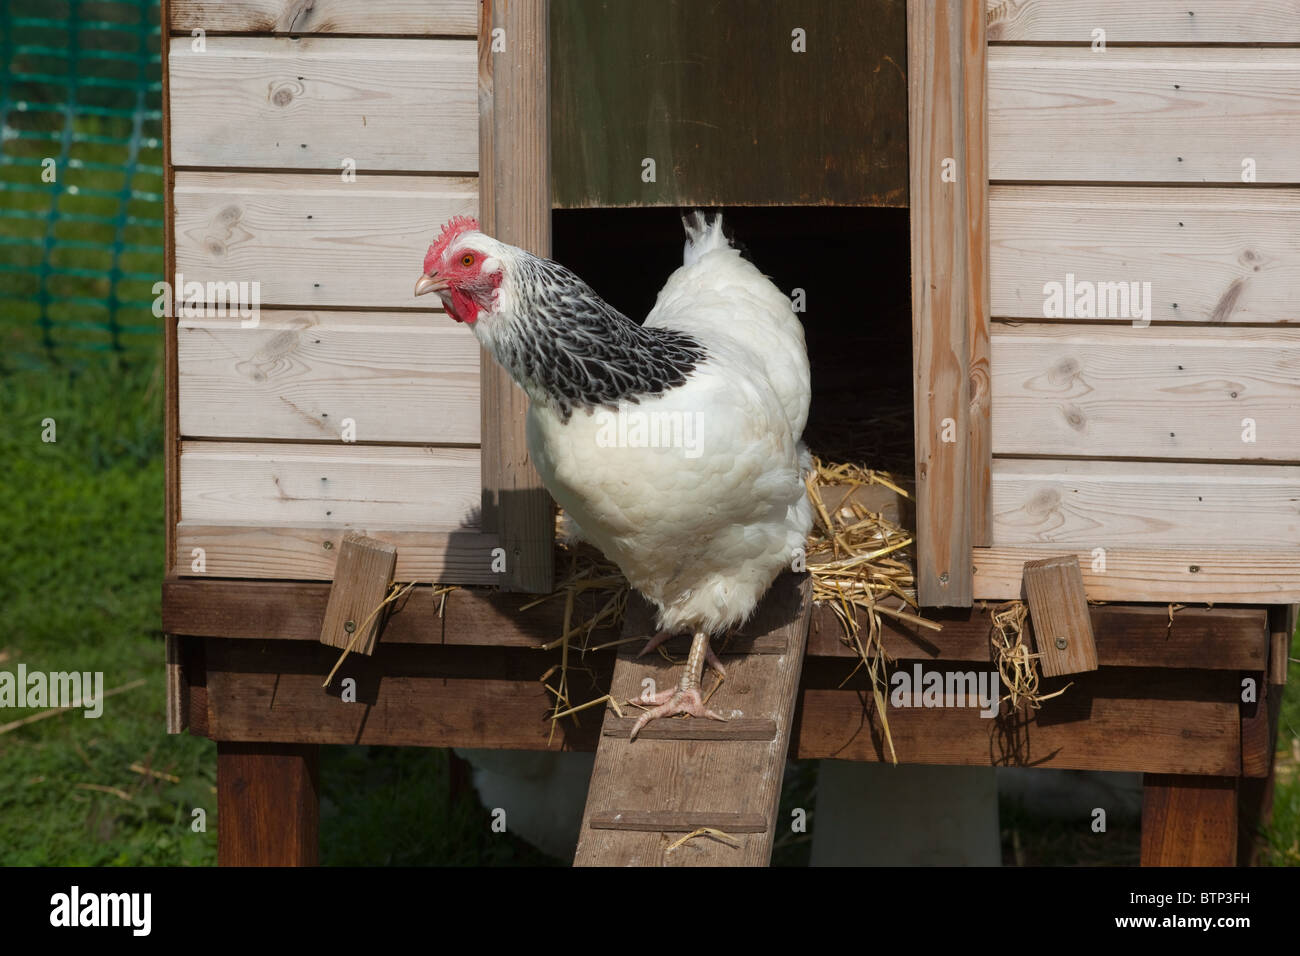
[163,0,1300,864]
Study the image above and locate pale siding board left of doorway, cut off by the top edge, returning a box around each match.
[169,0,478,36]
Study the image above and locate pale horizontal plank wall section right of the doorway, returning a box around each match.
[974,18,1300,602]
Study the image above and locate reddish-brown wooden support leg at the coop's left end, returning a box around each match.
[217,740,320,866]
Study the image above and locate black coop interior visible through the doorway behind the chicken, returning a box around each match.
[553,206,914,477]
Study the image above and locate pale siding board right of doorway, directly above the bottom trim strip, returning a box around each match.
[987,458,1300,553]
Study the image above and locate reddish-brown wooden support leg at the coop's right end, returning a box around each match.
[1141,774,1236,866]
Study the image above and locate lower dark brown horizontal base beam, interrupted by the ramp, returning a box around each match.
[191,640,1242,777]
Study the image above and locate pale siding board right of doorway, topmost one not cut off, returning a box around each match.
[988,47,1300,183]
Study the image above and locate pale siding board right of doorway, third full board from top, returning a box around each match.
[992,323,1300,462]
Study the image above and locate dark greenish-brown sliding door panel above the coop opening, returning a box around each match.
[550,0,907,208]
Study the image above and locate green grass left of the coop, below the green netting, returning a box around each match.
[0,363,216,865]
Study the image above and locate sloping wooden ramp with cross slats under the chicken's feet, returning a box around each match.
[575,574,813,866]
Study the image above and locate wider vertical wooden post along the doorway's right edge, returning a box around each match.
[907,0,976,607]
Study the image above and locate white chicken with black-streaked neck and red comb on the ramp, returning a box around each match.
[415,212,813,739]
